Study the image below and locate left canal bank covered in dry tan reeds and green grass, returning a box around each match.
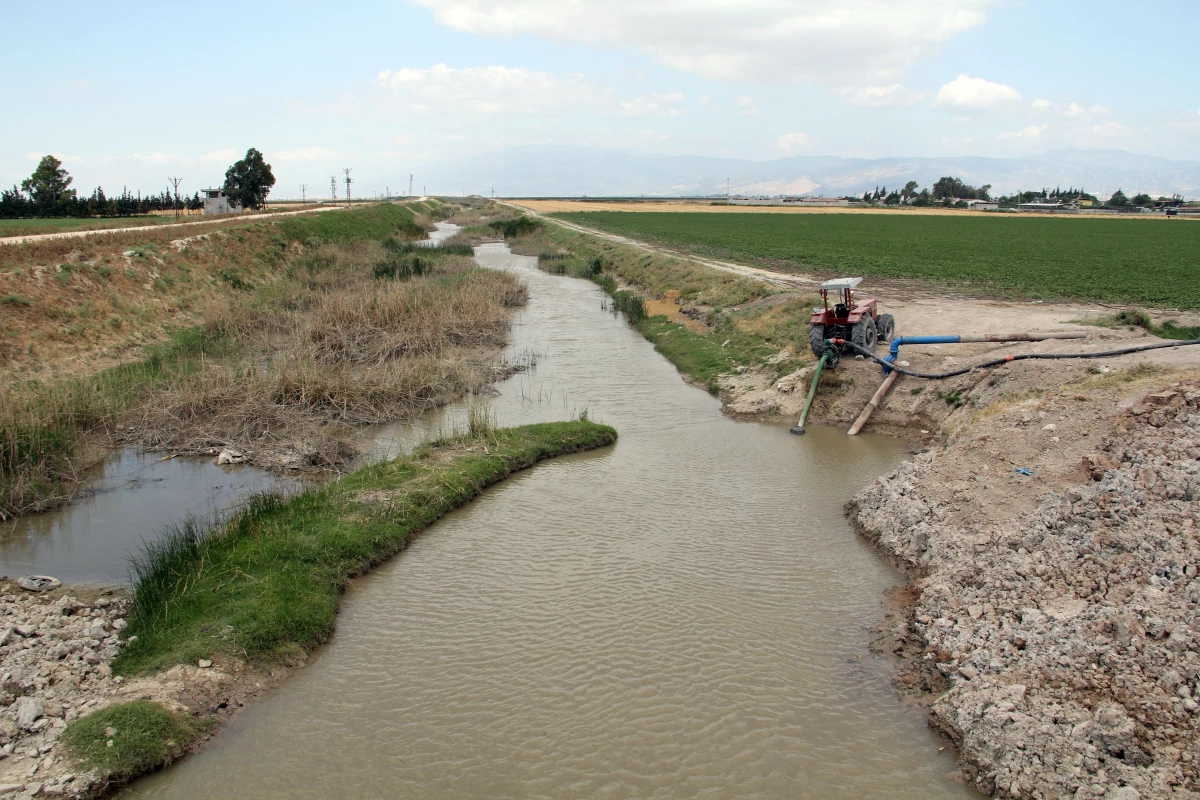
[0,205,524,516]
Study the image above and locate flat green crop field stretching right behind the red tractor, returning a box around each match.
[552,211,1200,308]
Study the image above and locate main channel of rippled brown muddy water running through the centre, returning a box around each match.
[125,245,973,799]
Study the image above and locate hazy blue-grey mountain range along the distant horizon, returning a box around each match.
[394,146,1200,198]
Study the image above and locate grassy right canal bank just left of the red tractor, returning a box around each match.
[499,217,814,395]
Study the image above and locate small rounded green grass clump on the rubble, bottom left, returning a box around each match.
[62,700,206,783]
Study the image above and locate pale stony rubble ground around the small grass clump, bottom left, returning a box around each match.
[0,581,284,798]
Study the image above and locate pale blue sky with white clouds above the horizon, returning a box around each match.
[0,0,1200,197]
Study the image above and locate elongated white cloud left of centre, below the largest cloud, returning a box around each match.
[376,64,613,115]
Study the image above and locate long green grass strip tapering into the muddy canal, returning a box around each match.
[113,419,617,674]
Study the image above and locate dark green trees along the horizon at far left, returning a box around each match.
[0,148,275,218]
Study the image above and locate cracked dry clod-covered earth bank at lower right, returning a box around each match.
[848,381,1200,800]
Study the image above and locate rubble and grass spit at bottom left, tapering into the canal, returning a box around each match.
[0,420,617,798]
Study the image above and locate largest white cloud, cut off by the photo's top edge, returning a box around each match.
[416,0,994,85]
